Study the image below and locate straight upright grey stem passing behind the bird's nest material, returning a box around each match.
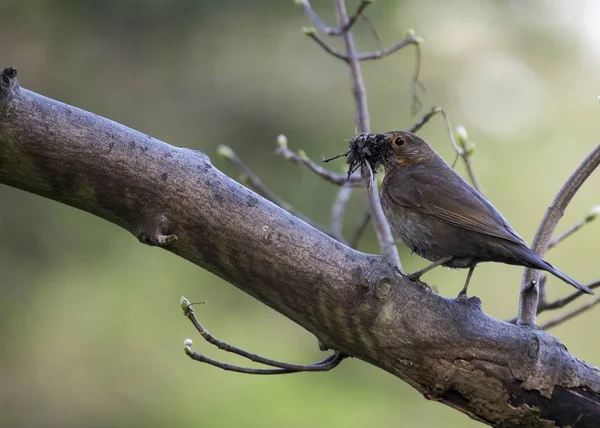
[335,0,402,269]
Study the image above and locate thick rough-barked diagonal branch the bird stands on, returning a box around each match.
[0,69,600,427]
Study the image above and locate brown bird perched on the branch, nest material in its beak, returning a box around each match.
[347,131,594,298]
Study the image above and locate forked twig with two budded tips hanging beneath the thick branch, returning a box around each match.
[181,297,346,375]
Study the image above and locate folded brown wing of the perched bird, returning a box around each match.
[386,168,526,245]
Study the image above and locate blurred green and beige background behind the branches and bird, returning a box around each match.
[0,0,600,427]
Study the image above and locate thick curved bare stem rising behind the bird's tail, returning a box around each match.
[517,144,600,325]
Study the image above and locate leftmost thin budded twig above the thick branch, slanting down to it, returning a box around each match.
[217,145,346,242]
